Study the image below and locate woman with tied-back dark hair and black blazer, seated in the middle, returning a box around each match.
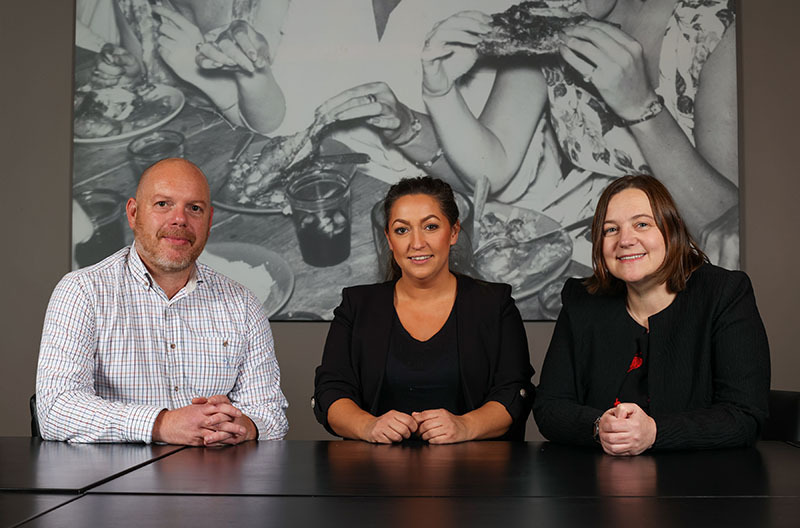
[312,177,534,444]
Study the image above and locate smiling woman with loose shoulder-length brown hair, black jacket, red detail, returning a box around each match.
[534,176,770,455]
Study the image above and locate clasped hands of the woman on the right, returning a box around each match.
[599,403,657,456]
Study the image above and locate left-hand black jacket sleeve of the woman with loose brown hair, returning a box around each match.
[533,279,605,446]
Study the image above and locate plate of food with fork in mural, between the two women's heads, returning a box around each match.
[472,202,572,299]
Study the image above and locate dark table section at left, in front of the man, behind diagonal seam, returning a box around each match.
[0,437,183,494]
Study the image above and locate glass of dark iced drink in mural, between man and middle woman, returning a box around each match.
[286,170,350,268]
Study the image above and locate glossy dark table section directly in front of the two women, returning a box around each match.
[91,441,800,497]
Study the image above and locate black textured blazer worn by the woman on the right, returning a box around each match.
[534,264,770,449]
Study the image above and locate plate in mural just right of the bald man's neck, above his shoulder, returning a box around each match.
[198,242,294,317]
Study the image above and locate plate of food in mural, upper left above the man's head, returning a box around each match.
[73,84,186,144]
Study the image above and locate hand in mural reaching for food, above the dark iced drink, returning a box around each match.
[317,82,419,144]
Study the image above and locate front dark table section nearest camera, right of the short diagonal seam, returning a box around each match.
[24,495,800,528]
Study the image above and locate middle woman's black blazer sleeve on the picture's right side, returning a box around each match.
[484,285,535,440]
